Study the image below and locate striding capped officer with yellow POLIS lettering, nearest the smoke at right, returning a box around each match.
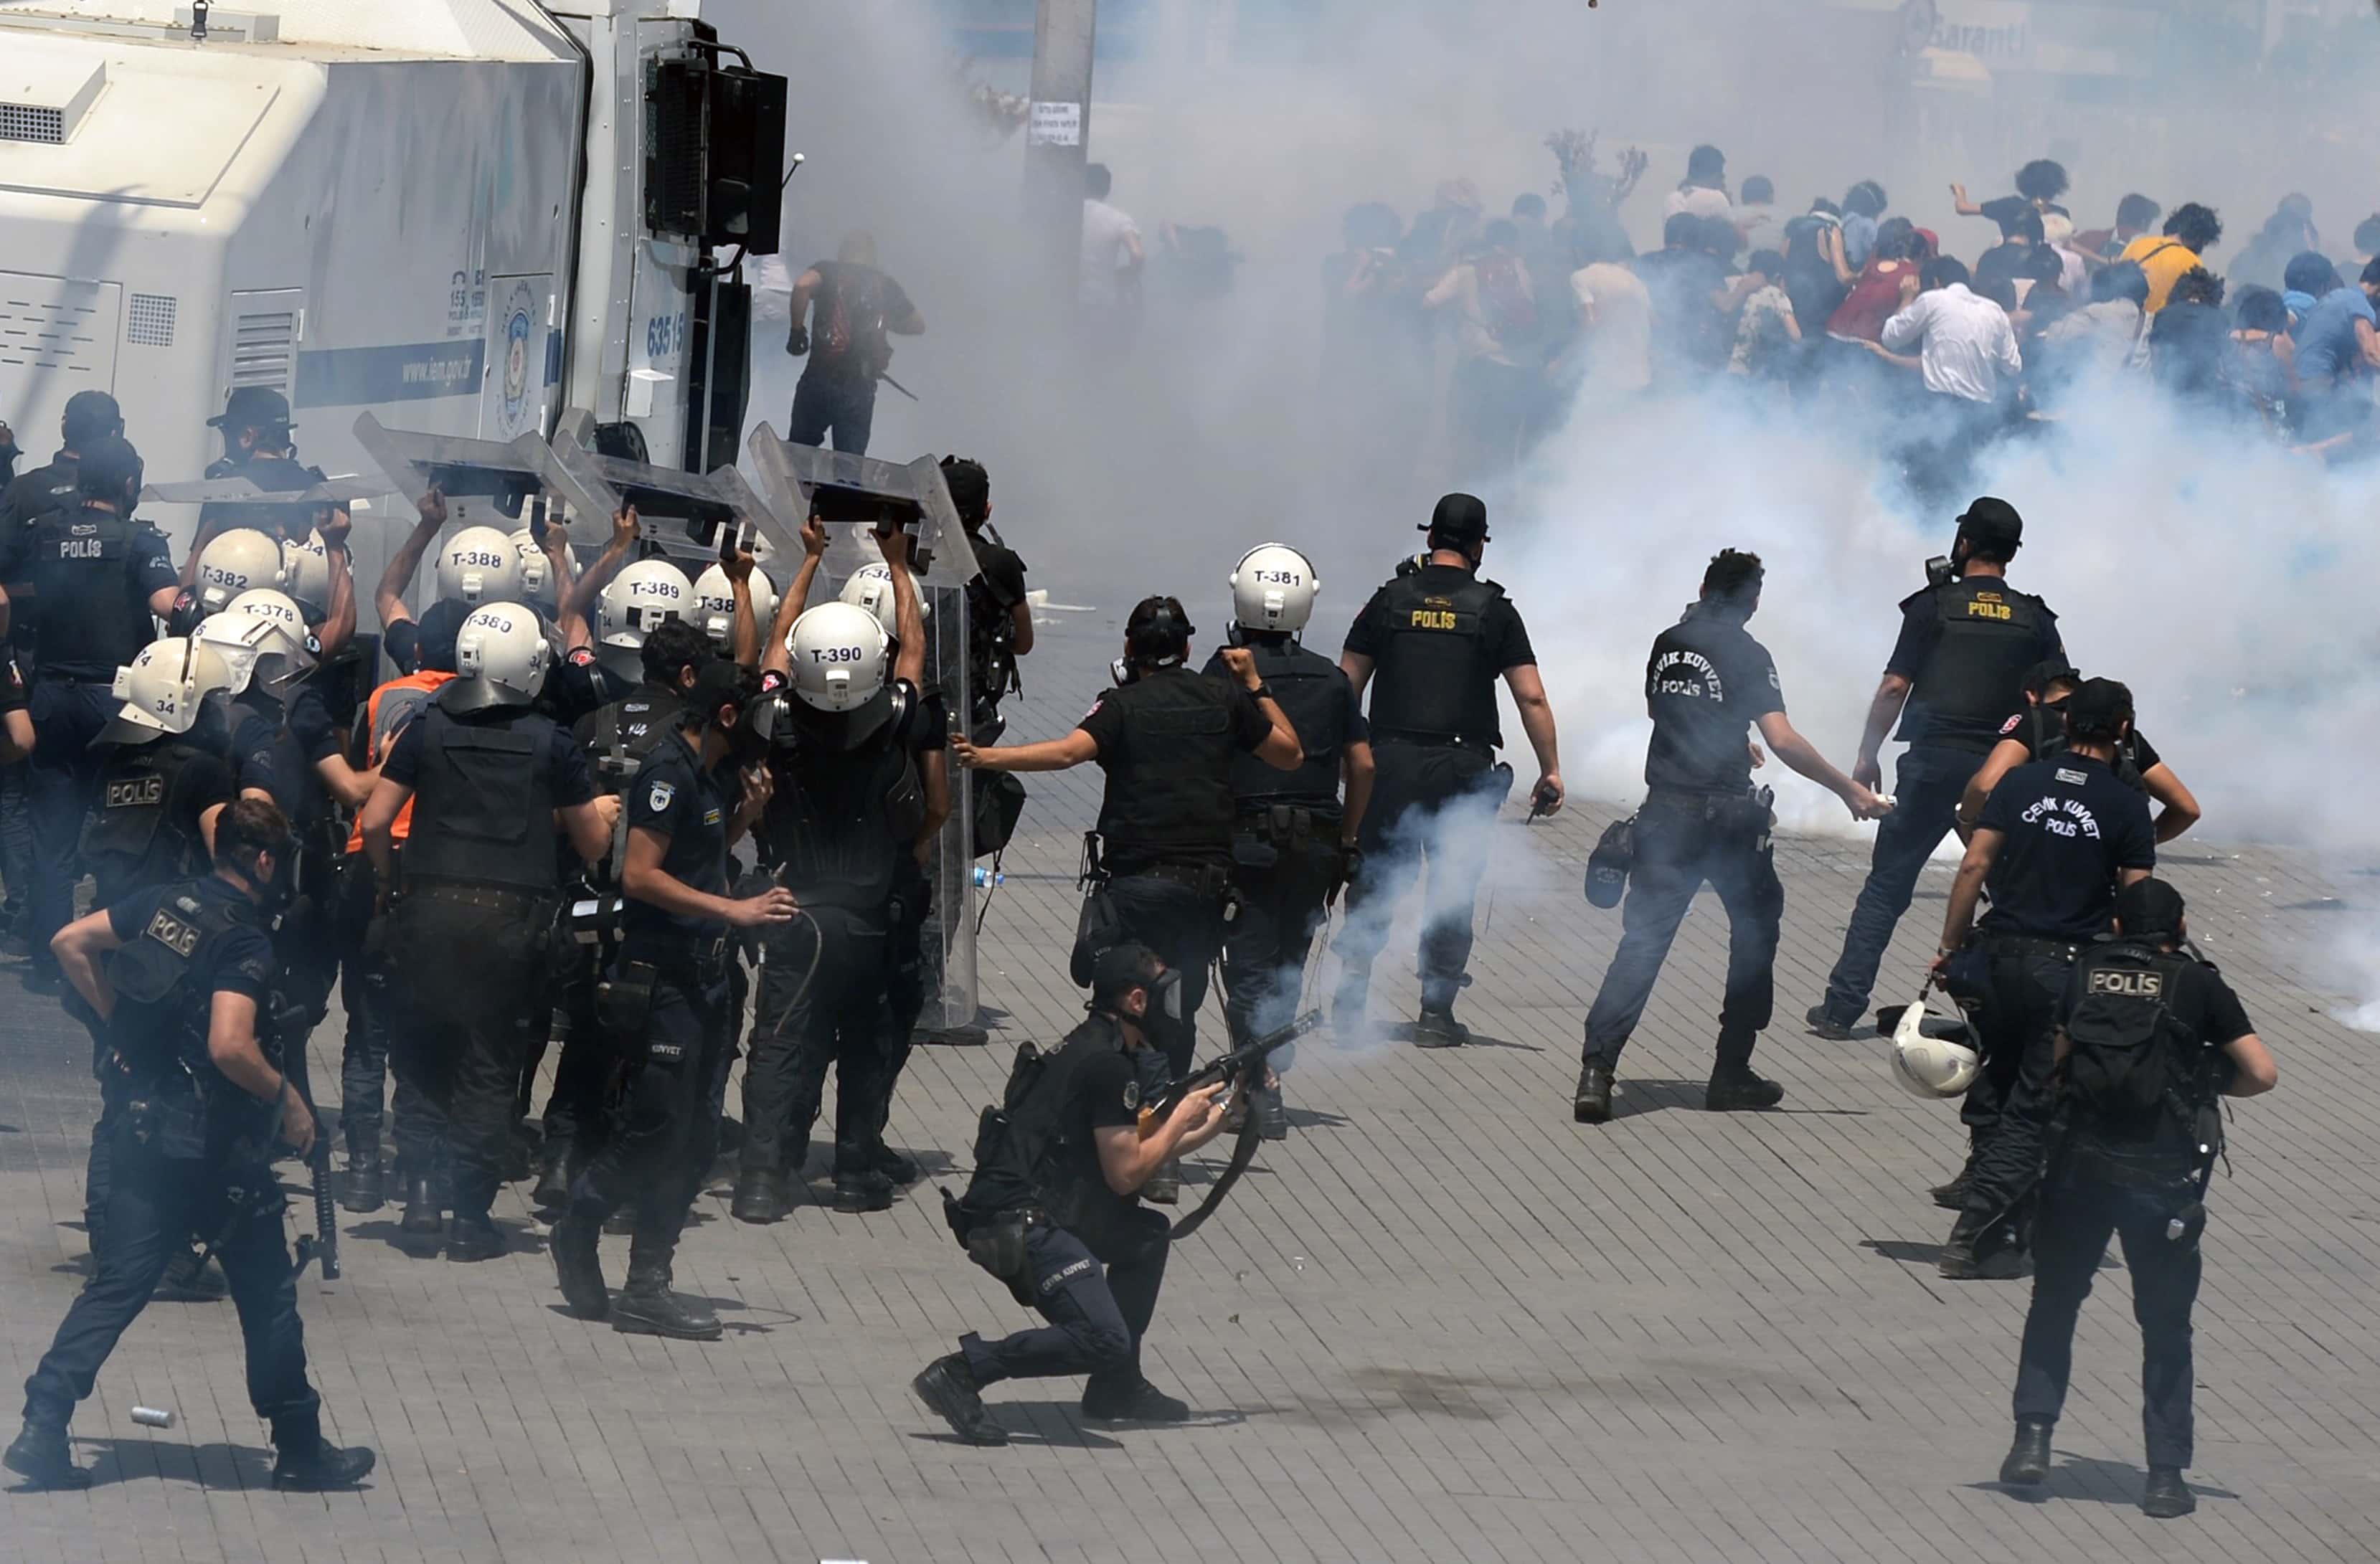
[1809,495,2064,1038]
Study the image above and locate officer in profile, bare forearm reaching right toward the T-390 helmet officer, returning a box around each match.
[549,660,795,1340]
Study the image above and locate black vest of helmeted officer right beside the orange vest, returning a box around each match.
[405,686,562,895]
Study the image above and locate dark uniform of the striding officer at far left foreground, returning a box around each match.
[24,876,338,1454]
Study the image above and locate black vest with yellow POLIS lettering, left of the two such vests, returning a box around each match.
[1361,572,1504,747]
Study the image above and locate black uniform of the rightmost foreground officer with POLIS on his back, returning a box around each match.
[2016,940,2256,1466]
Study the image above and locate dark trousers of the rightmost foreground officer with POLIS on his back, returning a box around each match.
[2016,1157,2199,1466]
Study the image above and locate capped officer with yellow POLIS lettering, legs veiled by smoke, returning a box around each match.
[1331,495,1562,1048]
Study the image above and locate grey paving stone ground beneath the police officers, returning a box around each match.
[0,626,2380,1564]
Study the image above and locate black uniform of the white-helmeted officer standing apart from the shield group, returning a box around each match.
[1206,633,1371,1043]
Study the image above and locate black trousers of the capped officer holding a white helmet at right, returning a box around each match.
[1959,936,2073,1254]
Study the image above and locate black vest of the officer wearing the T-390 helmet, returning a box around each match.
[764,688,926,914]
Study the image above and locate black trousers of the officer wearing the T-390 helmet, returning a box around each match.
[738,907,892,1176]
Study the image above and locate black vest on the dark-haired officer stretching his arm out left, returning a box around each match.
[1100,669,1240,873]
